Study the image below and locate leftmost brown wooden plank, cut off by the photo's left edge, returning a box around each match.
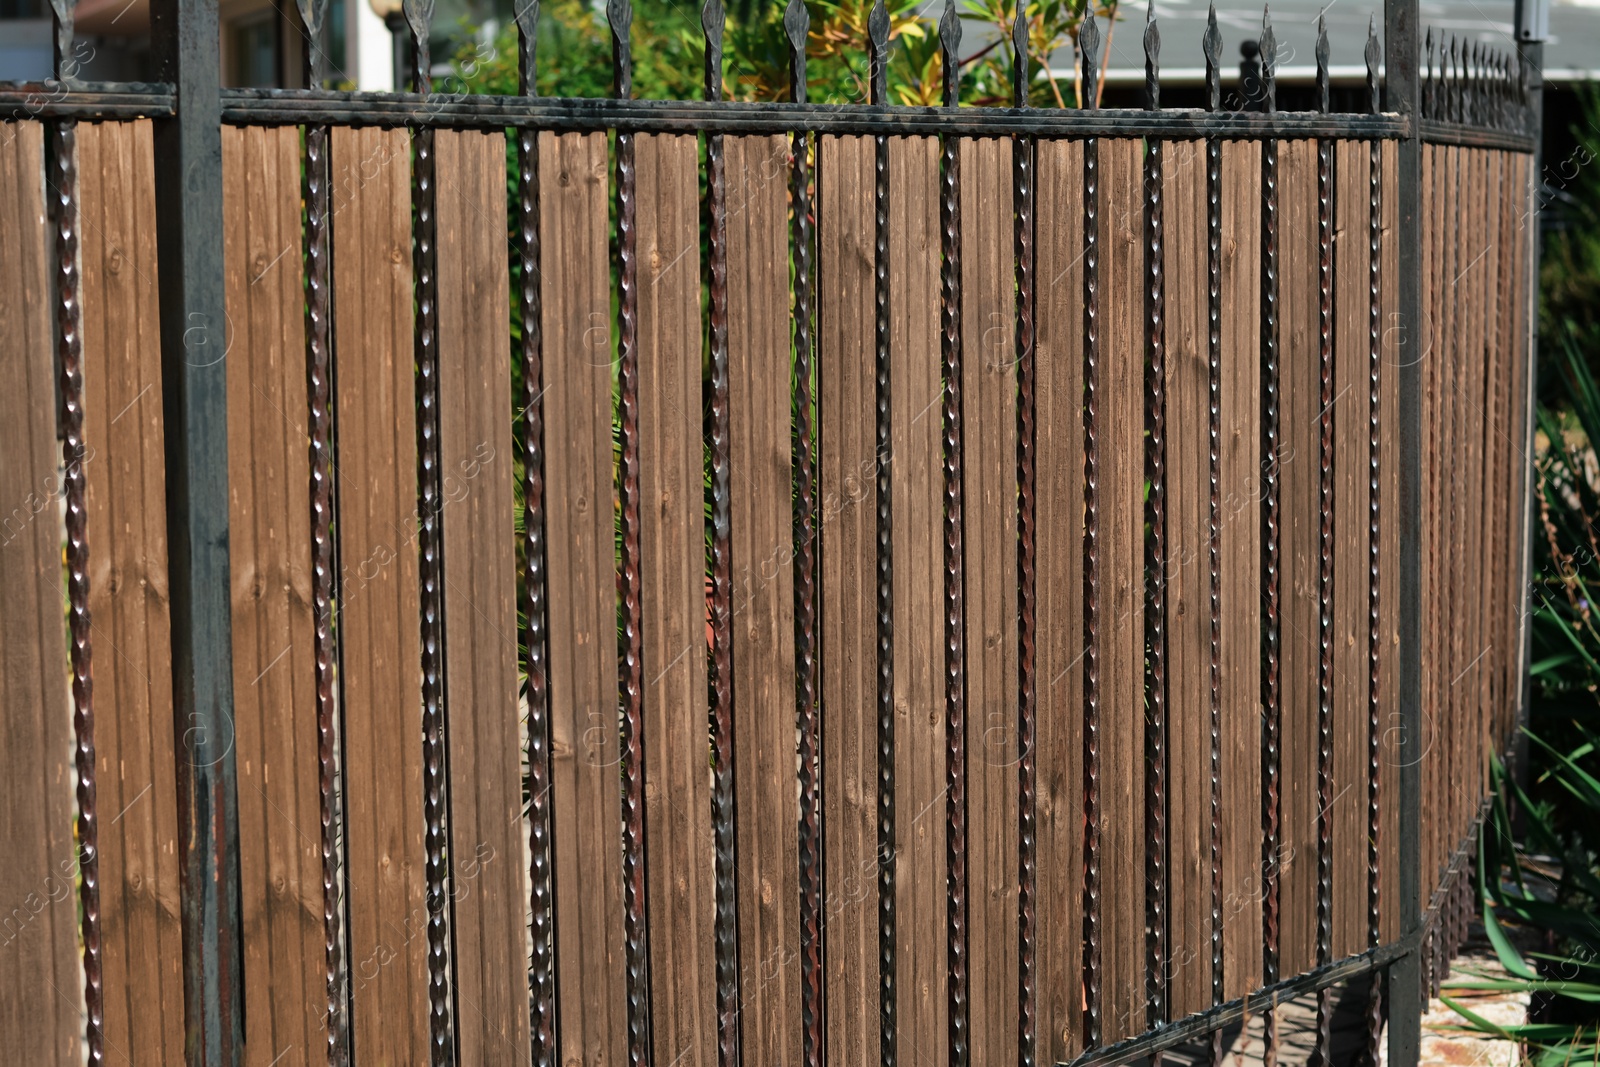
[0,122,82,1067]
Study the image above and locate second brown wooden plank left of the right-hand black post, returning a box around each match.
[1331,141,1371,960]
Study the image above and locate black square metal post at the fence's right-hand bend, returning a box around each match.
[1384,0,1422,1049]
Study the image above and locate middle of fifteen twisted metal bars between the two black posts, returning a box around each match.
[939,0,971,1067]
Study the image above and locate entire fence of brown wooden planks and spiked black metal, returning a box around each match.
[0,0,1538,1067]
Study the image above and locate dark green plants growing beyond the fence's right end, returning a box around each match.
[1465,86,1600,1067]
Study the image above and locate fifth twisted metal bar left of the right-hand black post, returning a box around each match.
[1144,0,1168,1027]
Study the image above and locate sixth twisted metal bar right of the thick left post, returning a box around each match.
[784,0,822,1067]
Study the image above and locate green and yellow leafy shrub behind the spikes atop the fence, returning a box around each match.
[440,0,1118,107]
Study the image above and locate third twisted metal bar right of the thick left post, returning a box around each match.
[515,0,557,1067]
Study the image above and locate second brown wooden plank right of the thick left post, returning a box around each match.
[331,128,429,1062]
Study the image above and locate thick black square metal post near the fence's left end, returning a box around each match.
[150,0,245,1067]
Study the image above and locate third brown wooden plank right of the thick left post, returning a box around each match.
[434,130,530,1062]
